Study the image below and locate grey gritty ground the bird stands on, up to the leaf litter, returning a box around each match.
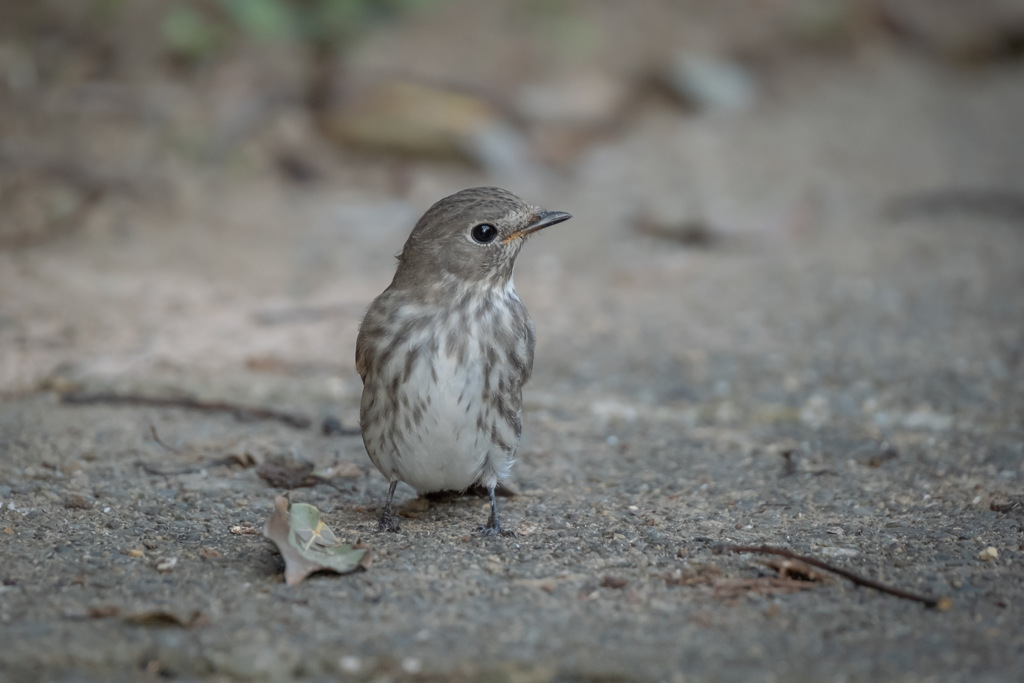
[0,29,1024,681]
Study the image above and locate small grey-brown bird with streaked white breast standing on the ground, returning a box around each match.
[355,187,572,536]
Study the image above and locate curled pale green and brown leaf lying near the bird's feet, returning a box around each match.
[263,496,370,586]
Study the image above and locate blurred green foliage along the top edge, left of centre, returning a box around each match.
[159,0,440,60]
